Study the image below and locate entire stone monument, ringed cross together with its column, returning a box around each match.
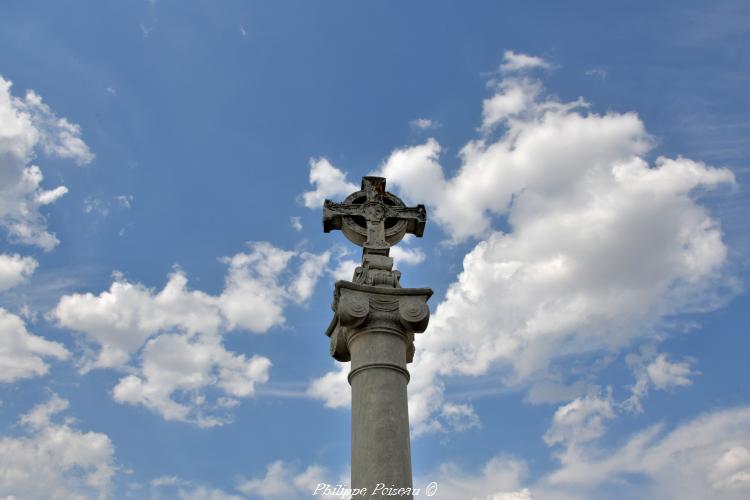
[323,177,432,498]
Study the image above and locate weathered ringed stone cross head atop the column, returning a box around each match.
[323,176,427,255]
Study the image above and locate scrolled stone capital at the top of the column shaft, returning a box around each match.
[326,281,432,363]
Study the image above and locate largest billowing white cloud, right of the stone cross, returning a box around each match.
[308,53,734,431]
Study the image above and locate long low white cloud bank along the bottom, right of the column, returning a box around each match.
[426,408,750,500]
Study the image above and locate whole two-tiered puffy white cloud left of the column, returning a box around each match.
[50,242,330,427]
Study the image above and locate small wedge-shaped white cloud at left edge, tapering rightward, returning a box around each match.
[0,307,70,383]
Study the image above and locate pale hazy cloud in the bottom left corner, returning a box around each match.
[0,396,117,498]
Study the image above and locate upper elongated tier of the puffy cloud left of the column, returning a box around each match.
[51,242,329,368]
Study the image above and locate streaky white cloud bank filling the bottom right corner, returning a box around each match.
[540,407,750,500]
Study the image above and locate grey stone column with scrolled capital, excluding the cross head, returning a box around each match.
[326,256,432,498]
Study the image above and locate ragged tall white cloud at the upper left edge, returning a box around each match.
[0,73,94,251]
